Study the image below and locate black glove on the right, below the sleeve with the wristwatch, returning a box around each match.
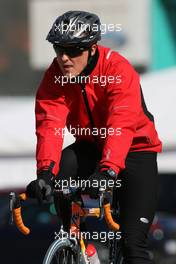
[86,168,117,199]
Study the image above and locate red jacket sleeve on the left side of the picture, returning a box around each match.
[35,71,68,175]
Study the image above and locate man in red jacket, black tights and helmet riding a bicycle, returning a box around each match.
[27,11,161,264]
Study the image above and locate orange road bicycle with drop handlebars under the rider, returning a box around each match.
[10,189,123,264]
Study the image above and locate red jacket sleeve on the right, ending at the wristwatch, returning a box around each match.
[100,61,141,173]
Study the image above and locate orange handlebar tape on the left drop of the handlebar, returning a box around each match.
[13,193,30,235]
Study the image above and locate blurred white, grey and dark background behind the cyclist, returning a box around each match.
[0,0,176,264]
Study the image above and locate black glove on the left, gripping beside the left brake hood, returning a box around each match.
[26,169,55,204]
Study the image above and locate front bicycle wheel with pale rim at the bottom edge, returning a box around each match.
[43,239,79,264]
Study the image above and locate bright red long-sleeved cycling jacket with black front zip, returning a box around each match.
[35,46,162,174]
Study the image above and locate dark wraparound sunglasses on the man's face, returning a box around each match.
[53,45,87,58]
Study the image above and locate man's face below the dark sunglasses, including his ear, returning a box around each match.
[57,45,96,77]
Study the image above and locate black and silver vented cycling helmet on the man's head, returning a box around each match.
[46,11,101,48]
